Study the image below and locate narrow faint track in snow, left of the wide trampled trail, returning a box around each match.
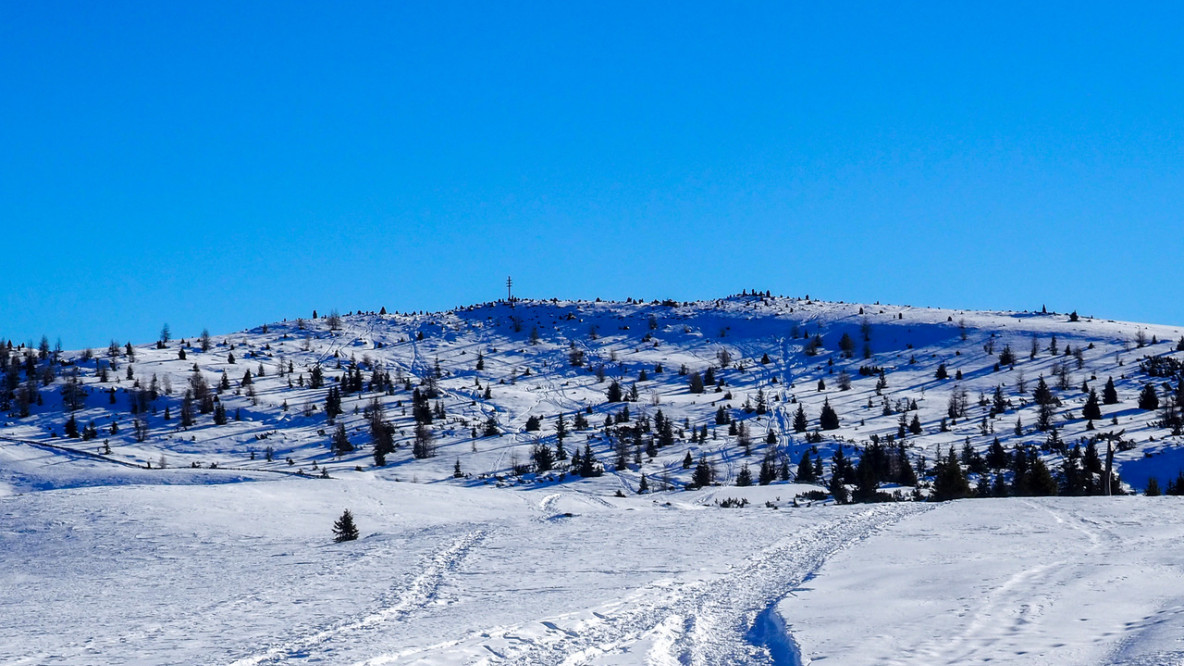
[231,530,487,666]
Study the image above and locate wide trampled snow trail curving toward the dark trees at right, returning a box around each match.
[359,498,931,666]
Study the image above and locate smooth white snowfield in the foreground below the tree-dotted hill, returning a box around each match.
[0,471,1184,666]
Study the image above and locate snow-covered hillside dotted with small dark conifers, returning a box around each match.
[0,290,1184,492]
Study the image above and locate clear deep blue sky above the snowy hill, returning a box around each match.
[0,1,1184,348]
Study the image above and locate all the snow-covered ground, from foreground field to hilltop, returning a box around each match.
[0,296,1184,665]
